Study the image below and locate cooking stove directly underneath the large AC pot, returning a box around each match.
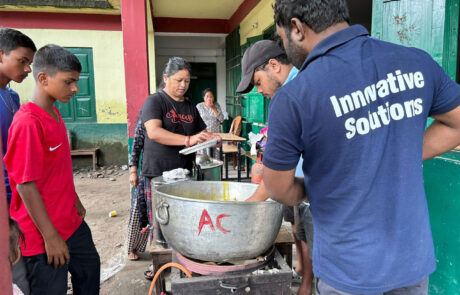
[170,248,292,295]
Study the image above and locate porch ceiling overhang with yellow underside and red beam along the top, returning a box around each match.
[0,0,260,34]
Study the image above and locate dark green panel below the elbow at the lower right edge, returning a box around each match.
[423,151,460,295]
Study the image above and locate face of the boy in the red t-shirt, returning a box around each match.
[44,71,80,103]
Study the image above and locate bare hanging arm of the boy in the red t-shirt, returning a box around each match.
[16,181,69,268]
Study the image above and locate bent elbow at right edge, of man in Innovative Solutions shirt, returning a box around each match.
[423,106,460,161]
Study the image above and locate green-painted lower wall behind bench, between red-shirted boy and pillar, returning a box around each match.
[66,123,128,167]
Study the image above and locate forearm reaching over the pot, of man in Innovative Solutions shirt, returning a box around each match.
[264,165,305,206]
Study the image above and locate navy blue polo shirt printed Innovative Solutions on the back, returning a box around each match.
[263,25,460,294]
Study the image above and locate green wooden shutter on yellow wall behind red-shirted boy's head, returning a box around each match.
[56,48,97,122]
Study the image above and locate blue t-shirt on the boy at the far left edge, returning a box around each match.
[0,87,19,203]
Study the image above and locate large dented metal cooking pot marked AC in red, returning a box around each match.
[154,181,283,262]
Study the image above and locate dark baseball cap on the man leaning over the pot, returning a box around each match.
[236,40,285,93]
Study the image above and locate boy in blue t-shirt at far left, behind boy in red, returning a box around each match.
[0,28,37,204]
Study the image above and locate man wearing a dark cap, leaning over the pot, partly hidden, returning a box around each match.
[236,40,313,295]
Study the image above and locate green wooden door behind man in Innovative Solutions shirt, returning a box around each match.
[372,0,460,295]
